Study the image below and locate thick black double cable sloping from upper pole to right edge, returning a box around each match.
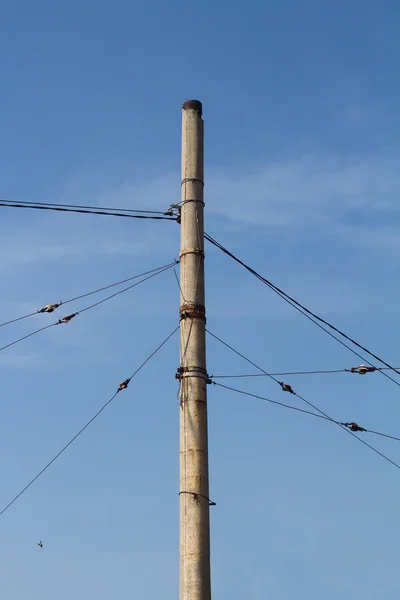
[204,233,400,387]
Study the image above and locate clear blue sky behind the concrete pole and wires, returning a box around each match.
[0,0,400,600]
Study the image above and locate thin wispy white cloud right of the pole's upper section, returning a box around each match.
[208,156,400,229]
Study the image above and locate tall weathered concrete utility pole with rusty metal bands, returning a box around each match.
[179,100,211,600]
